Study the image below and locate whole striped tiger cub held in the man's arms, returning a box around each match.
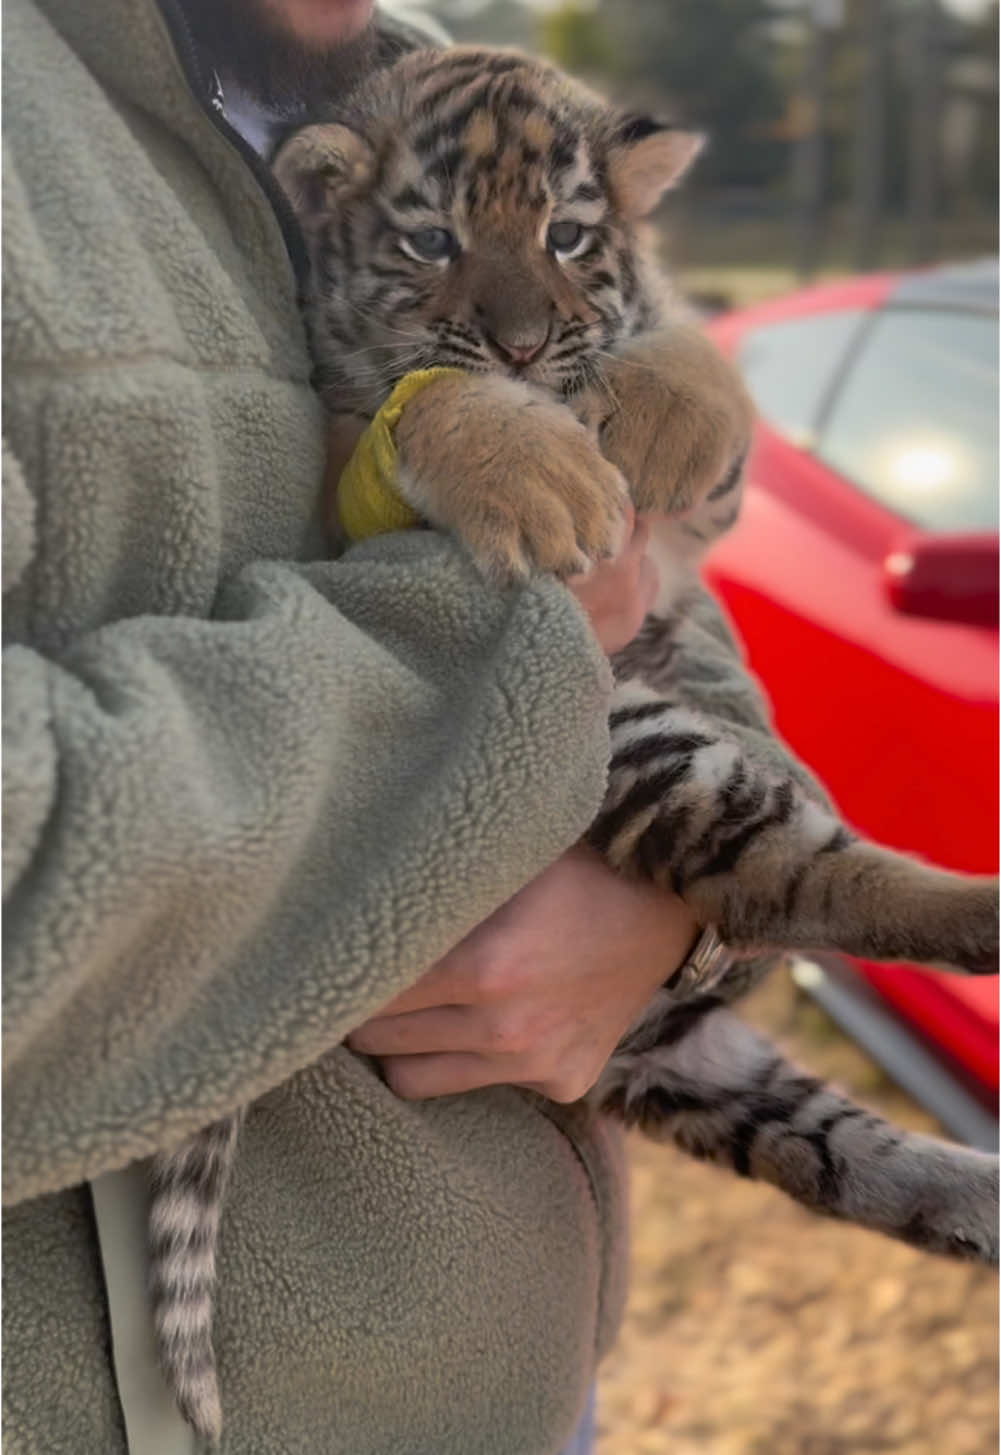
[151,49,998,1436]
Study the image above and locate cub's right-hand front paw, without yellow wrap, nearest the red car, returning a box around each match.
[590,322,754,540]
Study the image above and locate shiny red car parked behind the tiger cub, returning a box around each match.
[706,260,998,1145]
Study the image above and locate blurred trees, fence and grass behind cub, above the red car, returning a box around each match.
[432,0,998,304]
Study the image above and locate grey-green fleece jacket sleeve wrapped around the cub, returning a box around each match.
[3,512,608,1202]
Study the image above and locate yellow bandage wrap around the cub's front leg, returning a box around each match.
[331,368,461,541]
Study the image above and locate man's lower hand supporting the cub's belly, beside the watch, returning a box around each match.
[348,847,698,1101]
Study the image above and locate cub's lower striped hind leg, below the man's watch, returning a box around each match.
[589,991,998,1264]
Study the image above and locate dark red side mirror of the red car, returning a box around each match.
[883,534,1000,627]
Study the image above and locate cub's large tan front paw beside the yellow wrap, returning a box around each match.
[396,374,629,582]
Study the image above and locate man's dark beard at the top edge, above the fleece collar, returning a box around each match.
[182,0,377,115]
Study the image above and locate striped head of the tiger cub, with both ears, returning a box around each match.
[274,49,701,413]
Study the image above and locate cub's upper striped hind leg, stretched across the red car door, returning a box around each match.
[599,682,998,973]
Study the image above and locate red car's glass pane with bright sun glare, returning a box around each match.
[815,308,998,531]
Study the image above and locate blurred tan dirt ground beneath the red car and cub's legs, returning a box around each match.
[598,972,998,1455]
